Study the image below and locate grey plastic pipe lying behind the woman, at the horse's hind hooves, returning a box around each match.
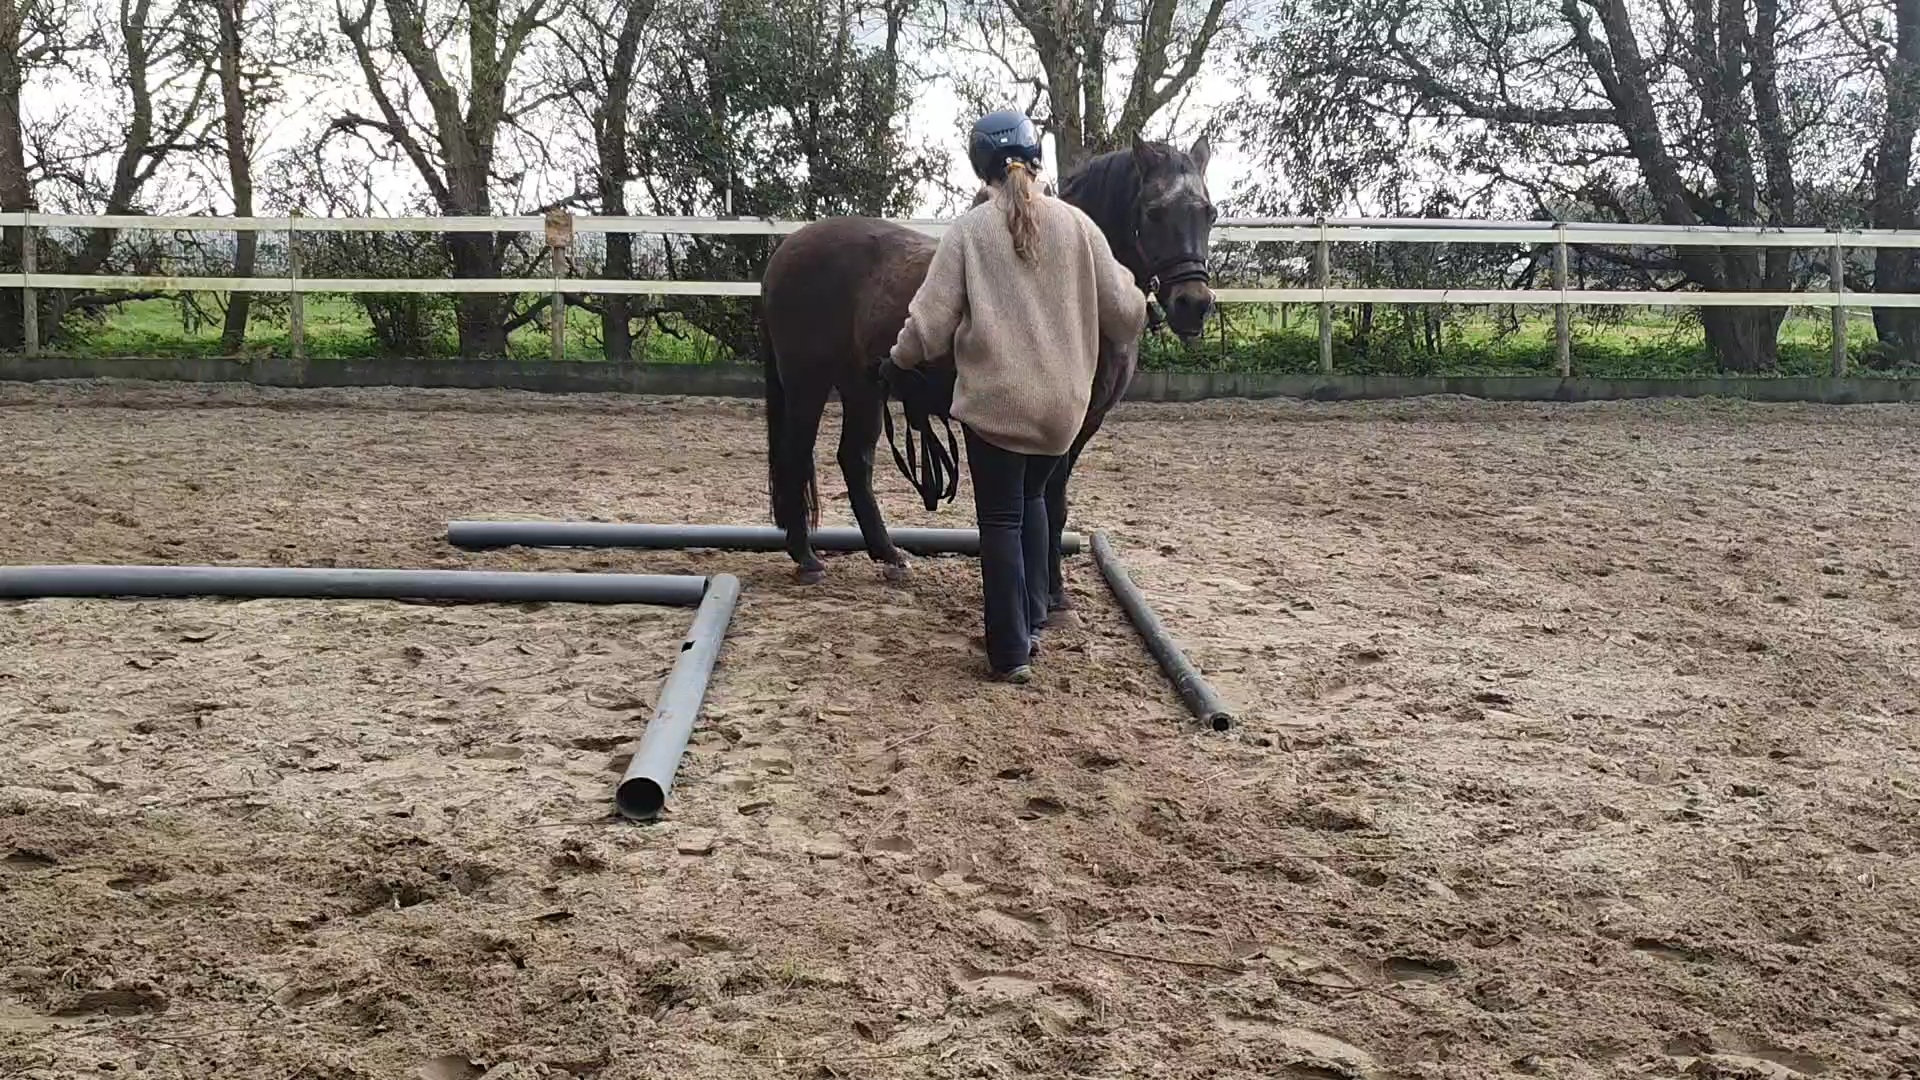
[447,521,1087,555]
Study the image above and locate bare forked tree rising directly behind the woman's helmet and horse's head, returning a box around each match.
[960,0,1244,175]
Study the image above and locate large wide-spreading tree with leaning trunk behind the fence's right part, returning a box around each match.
[1248,0,1832,371]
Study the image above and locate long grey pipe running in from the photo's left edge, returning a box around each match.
[0,565,707,607]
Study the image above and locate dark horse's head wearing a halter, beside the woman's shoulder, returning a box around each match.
[1133,136,1219,340]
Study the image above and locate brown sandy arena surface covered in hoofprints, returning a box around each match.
[0,384,1920,1080]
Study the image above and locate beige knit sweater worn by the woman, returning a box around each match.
[893,194,1146,454]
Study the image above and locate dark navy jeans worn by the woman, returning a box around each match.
[966,427,1064,675]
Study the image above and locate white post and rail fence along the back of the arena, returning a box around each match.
[0,211,1920,379]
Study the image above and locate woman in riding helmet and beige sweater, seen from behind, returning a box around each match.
[891,111,1146,682]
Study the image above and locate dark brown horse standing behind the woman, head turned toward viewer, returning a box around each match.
[760,138,1215,609]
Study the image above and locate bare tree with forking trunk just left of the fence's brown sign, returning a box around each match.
[334,0,559,357]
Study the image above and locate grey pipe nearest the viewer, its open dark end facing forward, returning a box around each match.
[612,575,739,821]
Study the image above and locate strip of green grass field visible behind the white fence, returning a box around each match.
[30,296,1920,379]
